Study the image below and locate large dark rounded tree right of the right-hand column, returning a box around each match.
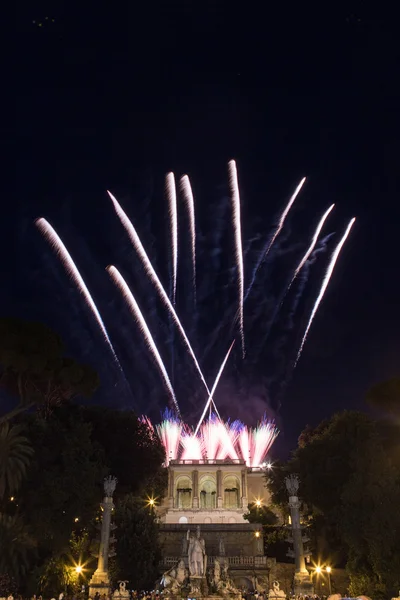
[278,411,400,597]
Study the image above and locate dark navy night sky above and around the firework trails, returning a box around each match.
[12,0,400,448]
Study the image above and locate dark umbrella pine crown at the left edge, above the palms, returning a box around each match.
[0,319,98,424]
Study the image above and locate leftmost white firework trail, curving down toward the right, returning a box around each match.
[35,217,122,358]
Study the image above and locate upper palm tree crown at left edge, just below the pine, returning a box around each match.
[0,423,33,500]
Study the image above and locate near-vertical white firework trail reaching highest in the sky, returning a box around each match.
[228,160,245,358]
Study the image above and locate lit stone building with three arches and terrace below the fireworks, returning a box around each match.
[158,459,276,590]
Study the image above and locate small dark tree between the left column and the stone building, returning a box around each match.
[115,494,161,589]
